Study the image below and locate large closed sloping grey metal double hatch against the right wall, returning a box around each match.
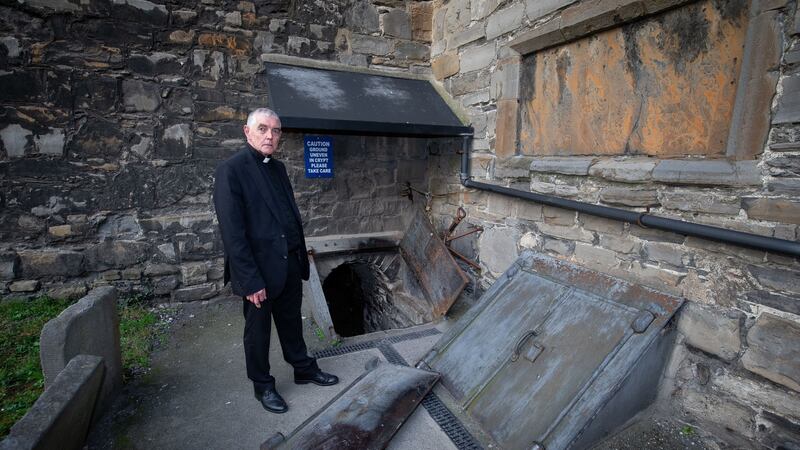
[424,252,682,449]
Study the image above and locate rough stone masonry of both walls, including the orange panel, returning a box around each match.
[0,0,800,447]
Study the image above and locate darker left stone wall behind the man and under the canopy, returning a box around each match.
[0,0,433,301]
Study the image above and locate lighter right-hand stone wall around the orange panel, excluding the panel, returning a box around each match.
[431,0,800,446]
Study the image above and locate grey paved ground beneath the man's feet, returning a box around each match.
[90,300,456,450]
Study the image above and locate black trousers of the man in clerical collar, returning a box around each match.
[244,248,319,390]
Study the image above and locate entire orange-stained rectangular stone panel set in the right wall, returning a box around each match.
[519,1,747,157]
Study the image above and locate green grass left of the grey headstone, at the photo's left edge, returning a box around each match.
[0,297,72,437]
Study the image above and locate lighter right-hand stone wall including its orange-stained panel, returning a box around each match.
[431,0,800,448]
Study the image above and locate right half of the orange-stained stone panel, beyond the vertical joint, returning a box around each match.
[631,3,746,157]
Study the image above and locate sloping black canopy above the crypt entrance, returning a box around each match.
[266,63,472,136]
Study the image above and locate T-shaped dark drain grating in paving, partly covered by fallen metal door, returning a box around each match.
[314,328,483,450]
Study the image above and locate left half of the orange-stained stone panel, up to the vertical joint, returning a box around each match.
[520,33,639,155]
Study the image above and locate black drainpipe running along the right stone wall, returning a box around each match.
[461,134,800,257]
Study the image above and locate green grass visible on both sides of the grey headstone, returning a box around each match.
[0,296,165,439]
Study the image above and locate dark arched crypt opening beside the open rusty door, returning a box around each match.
[322,261,398,337]
